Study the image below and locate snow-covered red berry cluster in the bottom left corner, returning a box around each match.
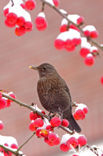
[0,135,18,156]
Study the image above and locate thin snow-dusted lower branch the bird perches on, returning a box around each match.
[2,93,74,134]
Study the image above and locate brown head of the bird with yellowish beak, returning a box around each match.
[29,63,57,78]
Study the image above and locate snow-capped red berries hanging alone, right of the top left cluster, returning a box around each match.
[35,12,47,31]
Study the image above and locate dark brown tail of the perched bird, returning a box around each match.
[68,115,81,133]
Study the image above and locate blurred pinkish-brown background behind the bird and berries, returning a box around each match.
[0,0,103,156]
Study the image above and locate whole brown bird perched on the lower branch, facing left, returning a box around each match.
[29,63,81,133]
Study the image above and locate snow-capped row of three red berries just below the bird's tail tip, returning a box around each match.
[60,133,87,152]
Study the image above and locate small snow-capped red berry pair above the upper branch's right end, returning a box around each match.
[83,25,98,38]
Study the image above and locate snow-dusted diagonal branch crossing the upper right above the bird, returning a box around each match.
[41,0,103,51]
